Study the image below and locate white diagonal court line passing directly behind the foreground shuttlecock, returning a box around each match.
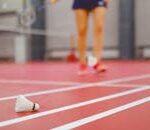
[0,74,150,101]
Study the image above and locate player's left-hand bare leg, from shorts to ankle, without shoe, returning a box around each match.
[75,9,89,64]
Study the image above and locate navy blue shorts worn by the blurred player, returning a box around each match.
[72,0,107,10]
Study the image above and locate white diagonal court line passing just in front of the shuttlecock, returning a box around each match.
[0,86,150,127]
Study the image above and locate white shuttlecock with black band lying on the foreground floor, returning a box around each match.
[15,95,40,112]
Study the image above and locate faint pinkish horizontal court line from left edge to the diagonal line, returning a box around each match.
[0,79,83,85]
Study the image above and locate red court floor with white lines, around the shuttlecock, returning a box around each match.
[0,60,150,130]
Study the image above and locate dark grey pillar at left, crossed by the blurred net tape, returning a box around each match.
[31,0,46,60]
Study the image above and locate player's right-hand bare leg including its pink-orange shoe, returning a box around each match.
[92,7,106,71]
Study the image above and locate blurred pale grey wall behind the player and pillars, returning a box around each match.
[0,0,150,61]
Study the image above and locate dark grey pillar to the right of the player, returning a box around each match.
[119,0,135,59]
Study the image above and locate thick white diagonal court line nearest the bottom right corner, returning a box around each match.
[51,97,150,130]
